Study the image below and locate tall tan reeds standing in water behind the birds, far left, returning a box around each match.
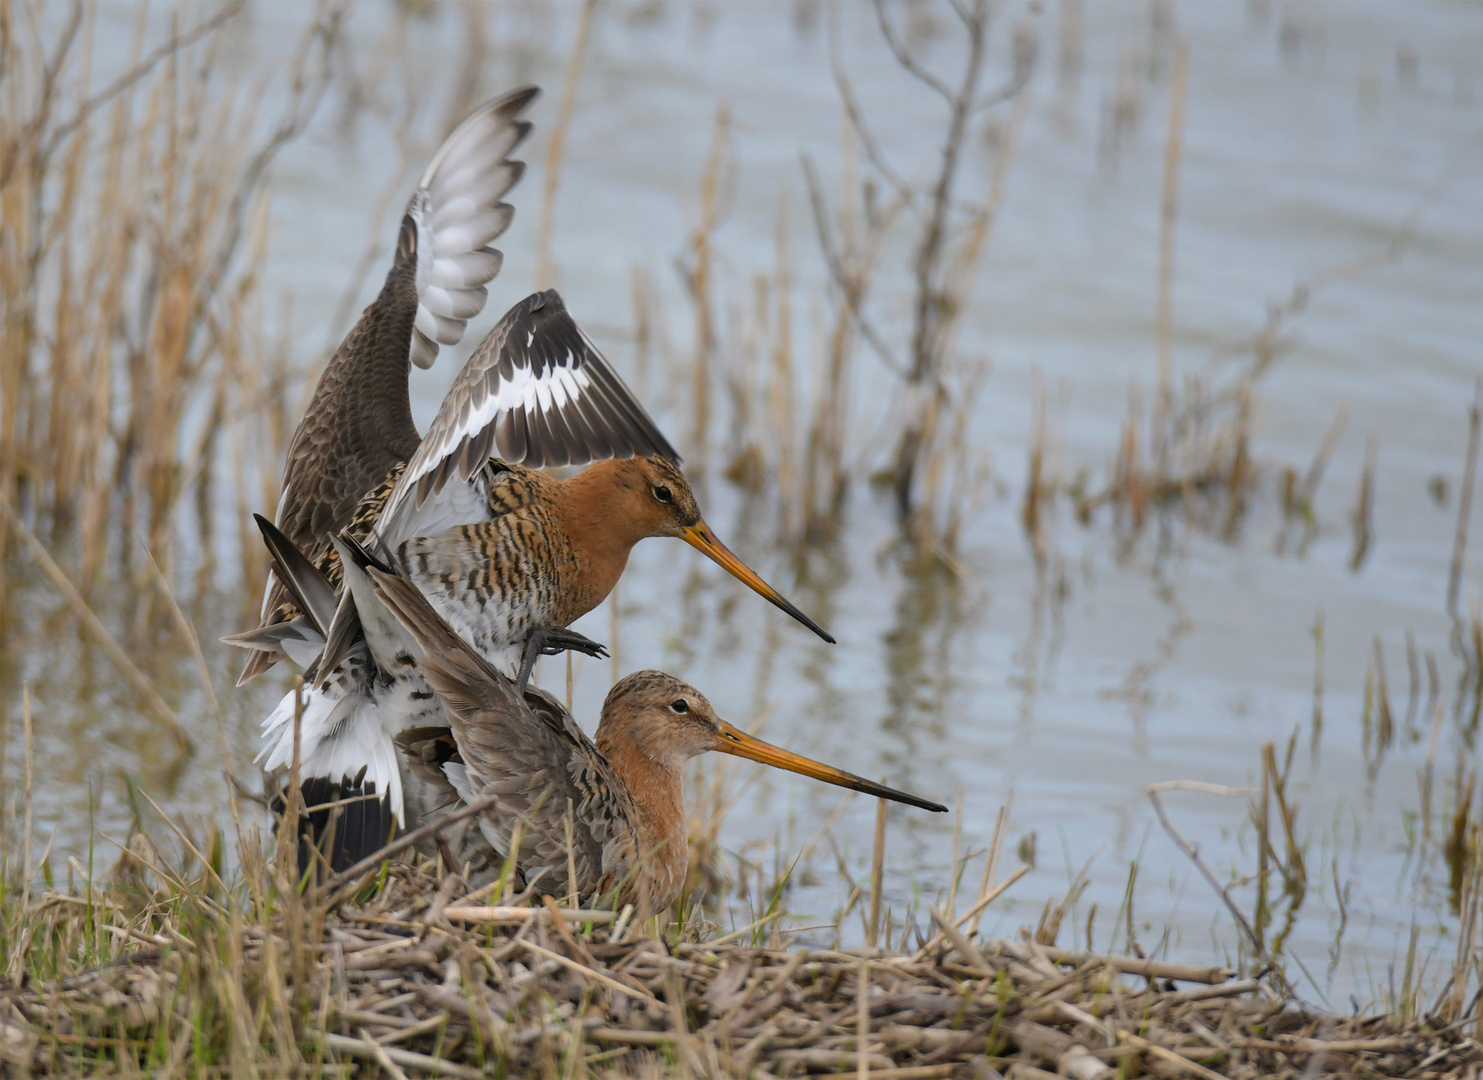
[0,3,346,625]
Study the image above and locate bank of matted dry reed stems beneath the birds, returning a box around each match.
[0,862,1483,1080]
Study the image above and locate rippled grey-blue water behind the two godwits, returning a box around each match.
[7,3,1483,1003]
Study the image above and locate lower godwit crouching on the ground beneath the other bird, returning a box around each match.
[369,570,948,911]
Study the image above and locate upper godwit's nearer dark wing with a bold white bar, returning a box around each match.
[377,289,679,544]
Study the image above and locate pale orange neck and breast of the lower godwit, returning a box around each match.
[598,727,690,911]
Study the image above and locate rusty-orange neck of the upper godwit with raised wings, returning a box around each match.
[559,460,648,611]
